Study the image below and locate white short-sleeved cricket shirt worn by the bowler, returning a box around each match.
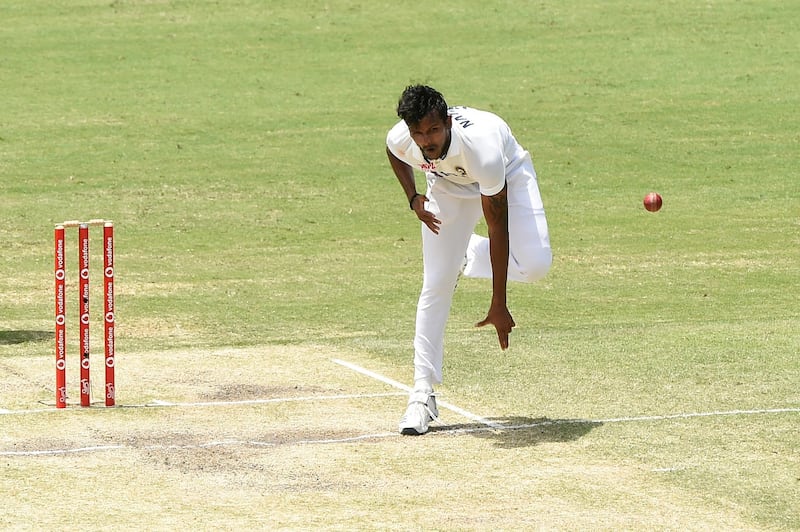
[386,107,530,196]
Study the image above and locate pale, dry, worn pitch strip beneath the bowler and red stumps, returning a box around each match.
[0,346,772,530]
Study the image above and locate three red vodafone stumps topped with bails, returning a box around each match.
[55,220,116,408]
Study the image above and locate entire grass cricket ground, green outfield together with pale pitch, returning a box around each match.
[0,0,800,530]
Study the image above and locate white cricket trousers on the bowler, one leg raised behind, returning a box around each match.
[414,157,552,391]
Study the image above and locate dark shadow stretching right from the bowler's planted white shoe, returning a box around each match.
[430,416,602,449]
